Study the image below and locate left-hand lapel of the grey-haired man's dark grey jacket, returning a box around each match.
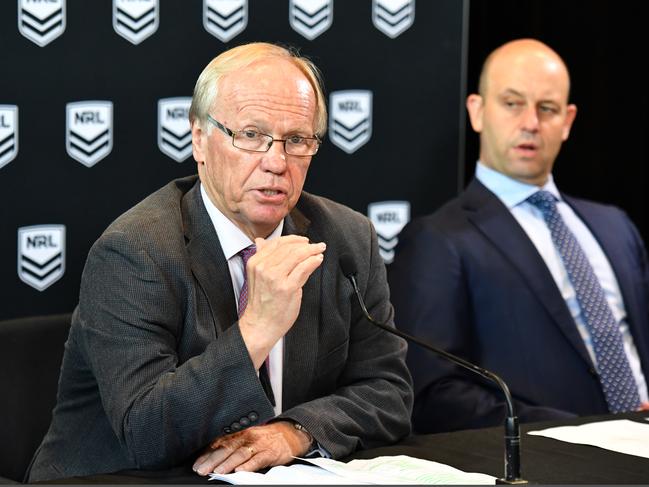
[182,182,238,334]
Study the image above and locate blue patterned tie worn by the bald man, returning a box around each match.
[527,191,640,413]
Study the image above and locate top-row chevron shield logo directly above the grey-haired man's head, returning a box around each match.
[203,0,248,42]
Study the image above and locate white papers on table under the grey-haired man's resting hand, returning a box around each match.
[210,455,496,485]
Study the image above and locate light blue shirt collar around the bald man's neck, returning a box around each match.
[475,161,561,210]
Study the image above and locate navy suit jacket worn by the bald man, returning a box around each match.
[388,180,649,432]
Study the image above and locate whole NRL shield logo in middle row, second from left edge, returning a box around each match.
[65,101,113,167]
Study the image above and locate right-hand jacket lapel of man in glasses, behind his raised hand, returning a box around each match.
[282,207,326,410]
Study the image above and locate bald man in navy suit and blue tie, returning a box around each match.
[388,39,649,432]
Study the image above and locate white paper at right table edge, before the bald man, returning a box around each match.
[528,419,649,458]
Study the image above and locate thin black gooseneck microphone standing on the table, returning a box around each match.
[339,254,527,485]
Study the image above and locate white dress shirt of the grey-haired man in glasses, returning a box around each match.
[201,184,284,414]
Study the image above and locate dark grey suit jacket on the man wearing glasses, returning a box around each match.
[29,176,412,481]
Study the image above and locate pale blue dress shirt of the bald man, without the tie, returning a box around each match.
[475,161,648,402]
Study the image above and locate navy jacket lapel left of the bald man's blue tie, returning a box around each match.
[463,180,591,364]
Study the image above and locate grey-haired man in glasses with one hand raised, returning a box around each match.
[29,43,412,481]
